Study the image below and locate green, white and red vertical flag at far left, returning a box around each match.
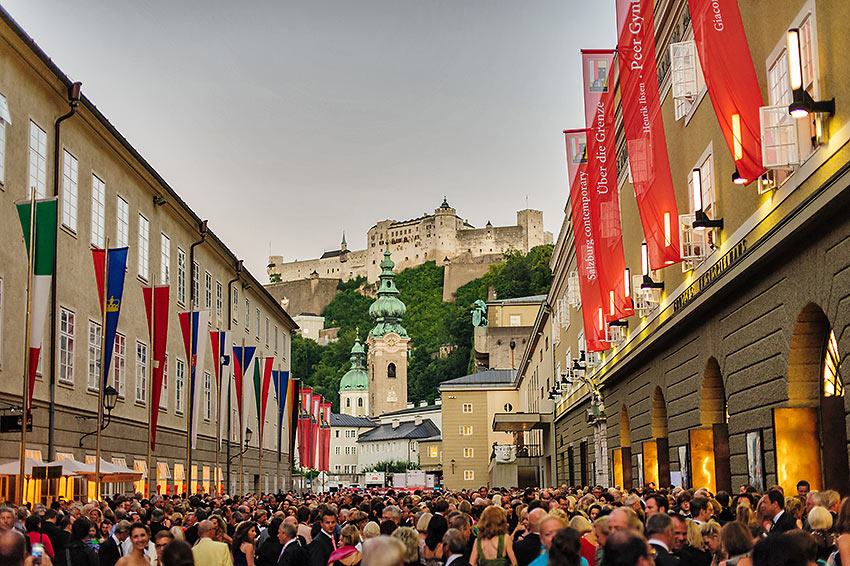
[15,197,57,413]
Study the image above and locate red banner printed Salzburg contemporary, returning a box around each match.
[564,130,610,352]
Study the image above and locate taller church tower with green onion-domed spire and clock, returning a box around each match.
[367,250,410,416]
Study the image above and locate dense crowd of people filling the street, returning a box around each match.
[0,481,850,566]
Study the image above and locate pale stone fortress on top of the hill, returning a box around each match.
[268,199,552,283]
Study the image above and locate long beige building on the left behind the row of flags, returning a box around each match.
[0,4,297,499]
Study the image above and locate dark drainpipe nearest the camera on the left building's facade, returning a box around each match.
[47,82,83,462]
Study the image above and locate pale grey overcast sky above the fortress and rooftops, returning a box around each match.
[2,0,615,281]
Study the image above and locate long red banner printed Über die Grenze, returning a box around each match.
[581,49,634,321]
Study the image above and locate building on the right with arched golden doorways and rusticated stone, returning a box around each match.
[540,0,850,494]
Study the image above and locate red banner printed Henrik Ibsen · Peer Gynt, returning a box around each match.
[617,0,682,269]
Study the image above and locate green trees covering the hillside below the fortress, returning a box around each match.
[292,245,552,411]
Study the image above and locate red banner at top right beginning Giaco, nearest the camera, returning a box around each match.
[688,0,765,183]
